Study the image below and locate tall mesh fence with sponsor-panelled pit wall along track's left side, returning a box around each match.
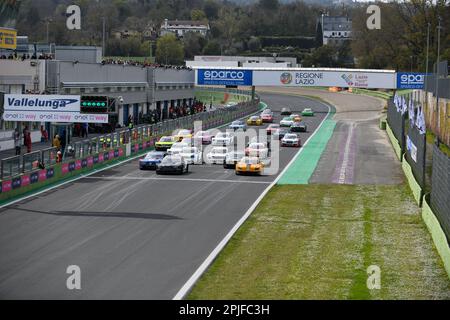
[0,99,261,201]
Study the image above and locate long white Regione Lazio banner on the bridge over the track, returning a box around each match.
[253,70,396,89]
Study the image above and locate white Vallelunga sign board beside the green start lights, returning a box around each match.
[3,94,108,123]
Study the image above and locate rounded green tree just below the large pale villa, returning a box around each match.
[156,33,184,65]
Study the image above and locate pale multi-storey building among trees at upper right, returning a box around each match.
[318,14,352,45]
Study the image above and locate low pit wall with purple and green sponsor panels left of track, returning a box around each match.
[0,101,262,204]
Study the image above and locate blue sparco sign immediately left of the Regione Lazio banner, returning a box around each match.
[197,69,253,86]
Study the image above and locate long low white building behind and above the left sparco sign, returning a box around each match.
[186,56,297,68]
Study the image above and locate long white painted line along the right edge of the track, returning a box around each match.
[173,100,331,300]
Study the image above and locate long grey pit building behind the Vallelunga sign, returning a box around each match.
[0,55,195,149]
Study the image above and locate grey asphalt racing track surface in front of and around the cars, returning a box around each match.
[0,94,328,299]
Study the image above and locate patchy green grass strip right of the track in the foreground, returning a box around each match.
[188,184,450,299]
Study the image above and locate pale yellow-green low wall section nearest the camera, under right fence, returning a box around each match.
[422,197,450,279]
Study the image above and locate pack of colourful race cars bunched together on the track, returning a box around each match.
[139,107,314,175]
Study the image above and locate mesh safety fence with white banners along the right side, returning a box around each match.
[387,90,450,239]
